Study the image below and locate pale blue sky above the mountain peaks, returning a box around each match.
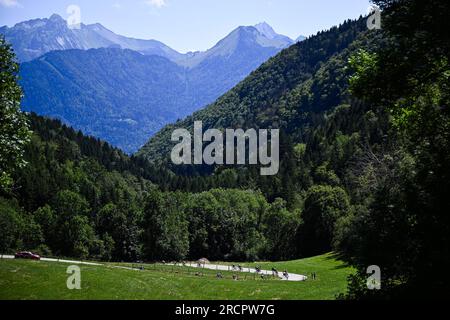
[0,0,369,52]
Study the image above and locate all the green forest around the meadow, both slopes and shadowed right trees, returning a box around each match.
[0,0,450,299]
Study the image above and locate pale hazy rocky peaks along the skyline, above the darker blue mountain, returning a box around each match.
[0,14,294,67]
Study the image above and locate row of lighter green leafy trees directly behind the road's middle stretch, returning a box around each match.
[143,189,300,261]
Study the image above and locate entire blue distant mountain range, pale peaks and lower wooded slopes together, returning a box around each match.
[0,15,306,153]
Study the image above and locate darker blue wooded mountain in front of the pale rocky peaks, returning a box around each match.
[21,49,187,152]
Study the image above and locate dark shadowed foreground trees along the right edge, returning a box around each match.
[338,0,450,299]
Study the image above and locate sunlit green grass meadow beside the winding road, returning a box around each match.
[0,254,353,300]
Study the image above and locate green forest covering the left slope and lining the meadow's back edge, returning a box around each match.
[0,114,300,261]
